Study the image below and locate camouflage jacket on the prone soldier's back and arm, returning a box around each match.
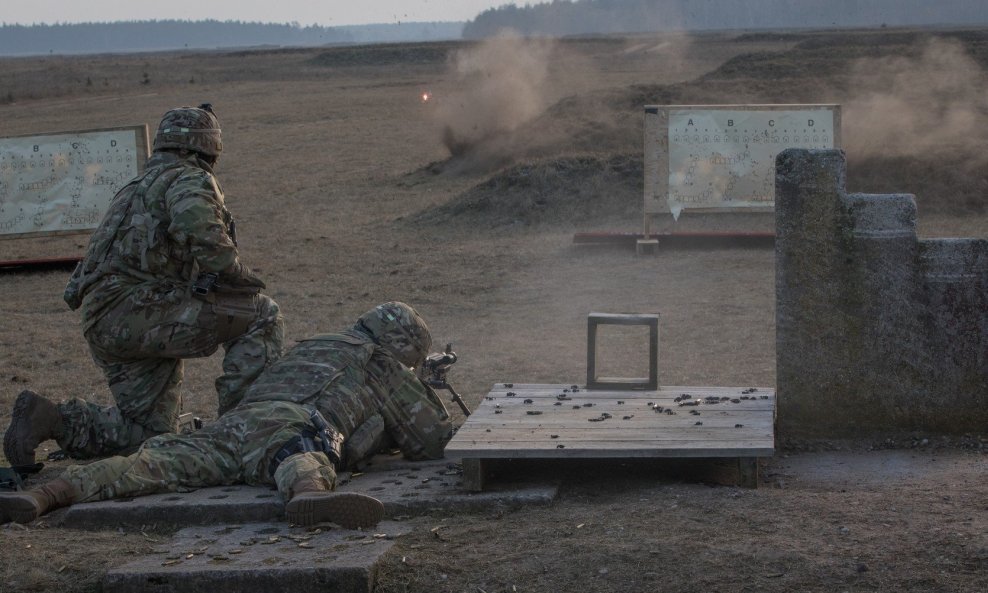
[242,329,453,461]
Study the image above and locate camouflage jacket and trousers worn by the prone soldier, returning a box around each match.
[62,303,452,502]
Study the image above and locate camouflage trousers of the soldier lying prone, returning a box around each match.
[61,401,336,502]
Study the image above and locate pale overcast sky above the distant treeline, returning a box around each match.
[0,0,524,27]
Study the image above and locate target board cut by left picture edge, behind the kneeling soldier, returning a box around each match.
[0,125,148,239]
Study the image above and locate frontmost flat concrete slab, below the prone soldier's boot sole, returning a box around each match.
[103,522,410,593]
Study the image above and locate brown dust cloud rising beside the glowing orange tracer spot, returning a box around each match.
[435,32,556,162]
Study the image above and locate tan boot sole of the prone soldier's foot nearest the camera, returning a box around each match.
[285,492,384,529]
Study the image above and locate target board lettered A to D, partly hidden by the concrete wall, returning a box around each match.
[645,105,840,219]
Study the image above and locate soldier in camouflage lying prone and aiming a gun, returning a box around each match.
[0,302,452,528]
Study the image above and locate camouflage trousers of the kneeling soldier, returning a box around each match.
[58,294,284,459]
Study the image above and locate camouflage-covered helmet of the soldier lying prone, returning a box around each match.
[357,301,432,367]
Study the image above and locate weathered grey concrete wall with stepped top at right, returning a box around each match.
[775,149,988,438]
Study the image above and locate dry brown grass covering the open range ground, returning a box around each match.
[0,27,988,591]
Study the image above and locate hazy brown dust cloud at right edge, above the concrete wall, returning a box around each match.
[843,39,988,164]
